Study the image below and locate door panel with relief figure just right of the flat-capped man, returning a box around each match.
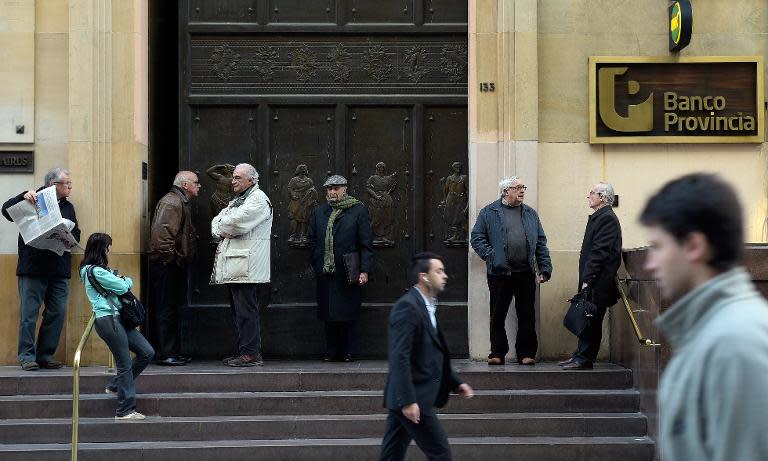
[345,107,414,303]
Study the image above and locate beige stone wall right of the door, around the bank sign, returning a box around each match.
[469,0,768,358]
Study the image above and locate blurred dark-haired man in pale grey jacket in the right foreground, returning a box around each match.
[640,174,768,461]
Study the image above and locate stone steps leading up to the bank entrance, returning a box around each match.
[0,360,654,461]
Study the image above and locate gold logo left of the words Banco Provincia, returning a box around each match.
[597,67,653,133]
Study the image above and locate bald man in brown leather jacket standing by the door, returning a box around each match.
[149,171,200,365]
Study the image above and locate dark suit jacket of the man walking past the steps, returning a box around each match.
[384,287,462,414]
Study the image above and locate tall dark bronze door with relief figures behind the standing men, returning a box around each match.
[179,0,469,356]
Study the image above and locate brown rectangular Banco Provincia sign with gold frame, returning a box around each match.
[589,56,765,144]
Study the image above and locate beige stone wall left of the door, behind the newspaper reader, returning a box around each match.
[0,0,148,364]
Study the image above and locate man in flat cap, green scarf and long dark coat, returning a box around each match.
[307,175,373,362]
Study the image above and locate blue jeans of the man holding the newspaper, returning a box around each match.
[18,275,69,364]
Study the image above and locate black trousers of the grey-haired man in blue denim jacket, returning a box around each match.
[488,272,539,360]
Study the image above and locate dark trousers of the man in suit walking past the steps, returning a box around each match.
[379,410,451,461]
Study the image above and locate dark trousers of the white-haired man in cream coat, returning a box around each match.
[227,283,269,355]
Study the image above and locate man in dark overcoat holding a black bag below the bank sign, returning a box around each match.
[560,182,621,370]
